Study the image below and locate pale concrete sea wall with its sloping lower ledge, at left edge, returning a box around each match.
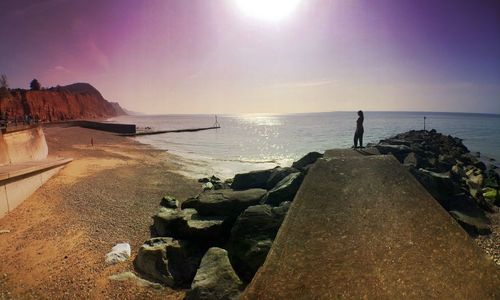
[0,126,71,218]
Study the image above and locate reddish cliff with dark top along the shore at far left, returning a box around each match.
[0,83,126,122]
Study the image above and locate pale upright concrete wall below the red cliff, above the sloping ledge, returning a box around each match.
[0,127,49,166]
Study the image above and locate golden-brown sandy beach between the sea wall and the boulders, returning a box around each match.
[0,127,201,299]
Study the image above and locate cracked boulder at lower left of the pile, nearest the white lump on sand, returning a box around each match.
[134,237,203,287]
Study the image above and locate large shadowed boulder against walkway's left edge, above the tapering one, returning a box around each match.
[228,202,290,282]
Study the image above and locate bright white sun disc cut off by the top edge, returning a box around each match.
[235,0,301,22]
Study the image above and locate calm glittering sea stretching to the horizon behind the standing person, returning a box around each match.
[108,111,500,178]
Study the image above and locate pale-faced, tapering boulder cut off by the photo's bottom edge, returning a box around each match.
[186,247,243,300]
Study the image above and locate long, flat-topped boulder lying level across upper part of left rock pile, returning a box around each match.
[182,189,267,216]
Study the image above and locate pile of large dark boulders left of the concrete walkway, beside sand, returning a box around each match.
[134,152,322,299]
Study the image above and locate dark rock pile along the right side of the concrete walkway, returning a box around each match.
[369,130,500,235]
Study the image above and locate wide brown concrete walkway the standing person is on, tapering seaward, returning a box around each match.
[242,154,500,299]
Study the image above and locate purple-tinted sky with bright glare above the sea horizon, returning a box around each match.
[0,0,500,114]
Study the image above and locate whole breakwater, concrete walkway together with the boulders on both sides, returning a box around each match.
[131,131,500,299]
